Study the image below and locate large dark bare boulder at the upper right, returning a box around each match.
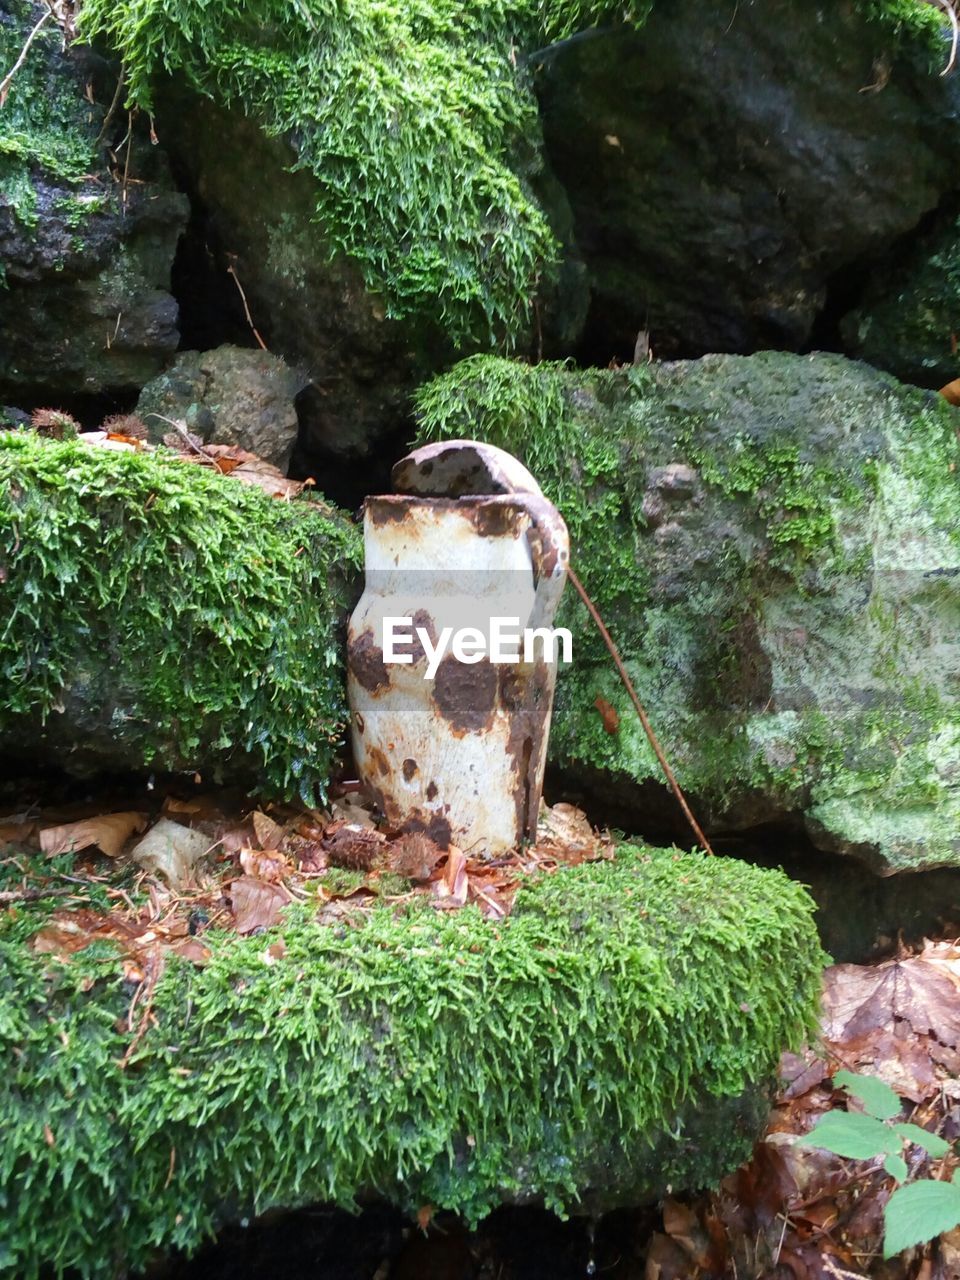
[536,0,960,364]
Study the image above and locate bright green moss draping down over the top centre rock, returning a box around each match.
[81,0,660,342]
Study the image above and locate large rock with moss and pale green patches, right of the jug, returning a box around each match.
[419,352,960,870]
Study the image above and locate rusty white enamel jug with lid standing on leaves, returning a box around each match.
[348,440,570,856]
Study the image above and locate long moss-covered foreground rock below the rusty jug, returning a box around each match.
[0,847,824,1280]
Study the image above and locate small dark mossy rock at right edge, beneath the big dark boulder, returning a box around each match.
[841,209,960,387]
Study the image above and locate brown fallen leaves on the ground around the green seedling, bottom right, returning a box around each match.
[645,941,960,1280]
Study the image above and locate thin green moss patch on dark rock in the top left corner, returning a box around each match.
[0,0,99,225]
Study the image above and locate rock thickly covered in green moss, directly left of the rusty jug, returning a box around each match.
[0,431,358,796]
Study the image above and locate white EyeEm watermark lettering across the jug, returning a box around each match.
[383,617,573,680]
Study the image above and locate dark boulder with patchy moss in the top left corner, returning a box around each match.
[0,0,187,402]
